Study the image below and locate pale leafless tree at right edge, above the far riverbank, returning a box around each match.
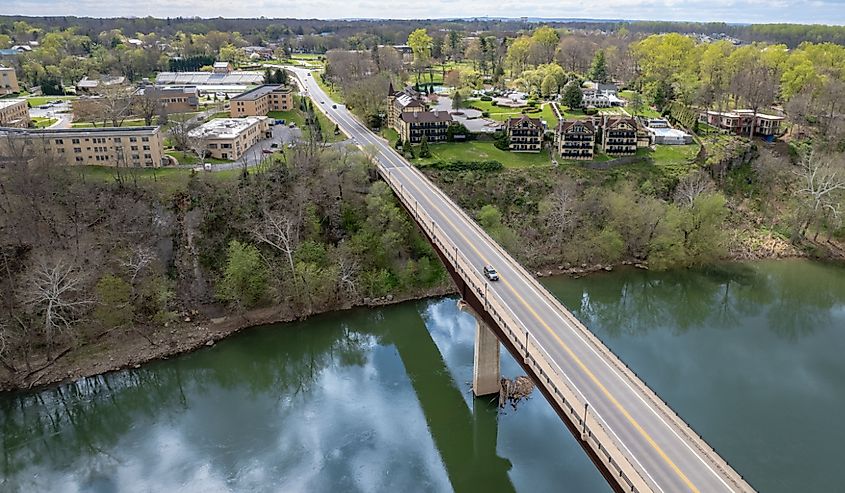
[794,149,845,238]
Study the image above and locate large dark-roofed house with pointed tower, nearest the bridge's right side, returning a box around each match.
[387,84,452,144]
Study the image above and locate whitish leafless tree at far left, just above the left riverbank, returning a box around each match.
[23,257,92,359]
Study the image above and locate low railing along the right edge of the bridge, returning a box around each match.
[390,158,754,491]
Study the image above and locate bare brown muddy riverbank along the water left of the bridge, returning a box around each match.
[0,284,455,392]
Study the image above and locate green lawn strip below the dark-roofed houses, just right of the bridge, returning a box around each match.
[413,141,551,168]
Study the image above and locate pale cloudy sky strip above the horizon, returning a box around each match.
[0,0,845,25]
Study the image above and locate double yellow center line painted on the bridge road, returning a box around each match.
[396,163,700,493]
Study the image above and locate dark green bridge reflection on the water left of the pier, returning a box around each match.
[384,306,515,493]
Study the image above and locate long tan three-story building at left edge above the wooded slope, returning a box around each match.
[0,127,164,167]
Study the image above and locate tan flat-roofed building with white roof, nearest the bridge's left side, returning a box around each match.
[188,116,271,161]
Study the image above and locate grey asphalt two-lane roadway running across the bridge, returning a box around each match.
[289,68,753,493]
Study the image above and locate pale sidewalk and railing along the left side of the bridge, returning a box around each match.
[379,167,652,492]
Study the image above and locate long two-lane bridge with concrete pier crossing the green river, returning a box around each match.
[287,67,754,493]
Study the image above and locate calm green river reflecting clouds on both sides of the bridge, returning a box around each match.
[0,261,845,493]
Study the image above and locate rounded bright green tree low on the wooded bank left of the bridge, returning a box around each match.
[217,240,268,307]
